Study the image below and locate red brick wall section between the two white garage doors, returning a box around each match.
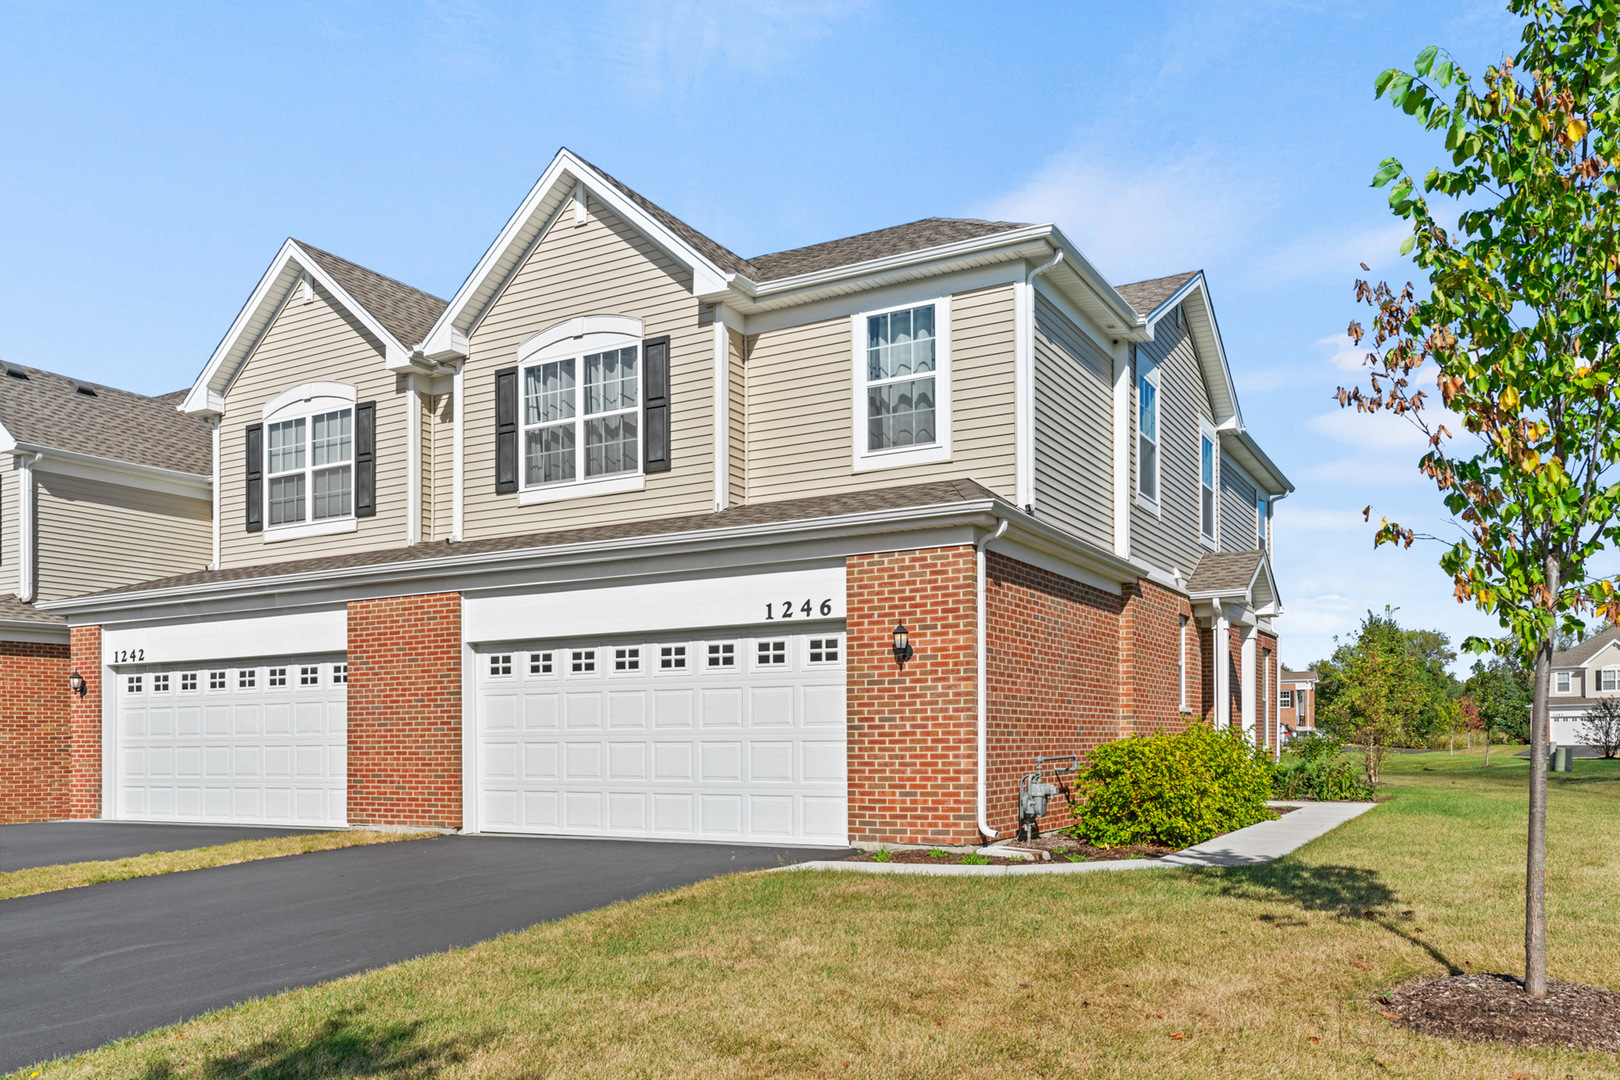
[348,593,462,829]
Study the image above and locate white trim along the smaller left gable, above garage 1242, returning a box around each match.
[180,240,411,415]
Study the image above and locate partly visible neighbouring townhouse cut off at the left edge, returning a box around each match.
[0,363,214,823]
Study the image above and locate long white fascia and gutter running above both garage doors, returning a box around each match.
[41,499,1144,625]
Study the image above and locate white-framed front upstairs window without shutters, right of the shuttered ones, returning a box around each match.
[852,298,951,471]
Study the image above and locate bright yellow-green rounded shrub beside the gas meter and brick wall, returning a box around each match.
[1076,722,1277,848]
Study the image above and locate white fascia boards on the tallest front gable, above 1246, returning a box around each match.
[421,149,731,359]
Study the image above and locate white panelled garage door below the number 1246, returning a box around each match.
[476,630,849,844]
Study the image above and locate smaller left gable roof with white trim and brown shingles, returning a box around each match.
[180,240,444,413]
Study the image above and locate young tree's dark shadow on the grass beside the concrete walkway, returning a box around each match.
[1202,858,1463,975]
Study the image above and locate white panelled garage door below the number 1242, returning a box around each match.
[113,657,348,826]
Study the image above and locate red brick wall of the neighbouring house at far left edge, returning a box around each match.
[0,641,73,824]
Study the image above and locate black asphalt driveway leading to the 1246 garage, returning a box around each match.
[0,836,851,1072]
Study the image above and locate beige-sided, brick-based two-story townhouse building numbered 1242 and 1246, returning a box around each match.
[38,151,1291,844]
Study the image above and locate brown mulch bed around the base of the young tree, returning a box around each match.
[1374,973,1620,1051]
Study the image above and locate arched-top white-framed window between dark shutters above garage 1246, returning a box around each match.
[517,316,645,502]
